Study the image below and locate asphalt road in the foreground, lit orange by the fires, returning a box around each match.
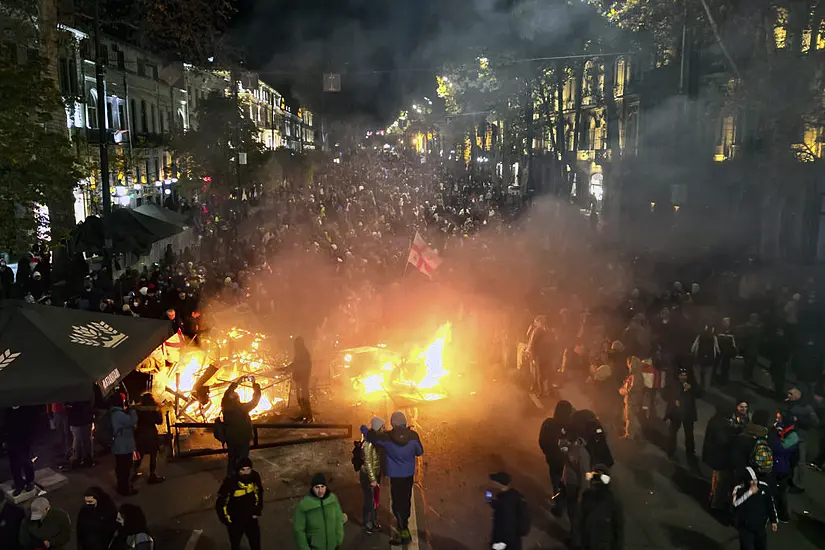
[30,360,825,550]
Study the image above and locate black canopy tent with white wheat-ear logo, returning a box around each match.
[0,300,173,408]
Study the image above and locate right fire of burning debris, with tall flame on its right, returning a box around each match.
[343,323,452,401]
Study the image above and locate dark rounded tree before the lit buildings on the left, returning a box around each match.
[172,92,263,197]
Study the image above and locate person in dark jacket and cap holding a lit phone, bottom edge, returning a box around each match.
[487,472,530,550]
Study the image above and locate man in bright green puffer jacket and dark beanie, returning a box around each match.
[295,474,344,550]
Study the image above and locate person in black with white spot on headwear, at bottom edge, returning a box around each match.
[579,464,624,550]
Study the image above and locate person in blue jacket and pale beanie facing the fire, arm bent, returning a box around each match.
[367,411,424,544]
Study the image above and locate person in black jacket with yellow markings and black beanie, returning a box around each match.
[215,457,264,550]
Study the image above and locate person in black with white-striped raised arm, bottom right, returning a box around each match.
[733,467,778,550]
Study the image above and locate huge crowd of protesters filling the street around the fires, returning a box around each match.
[0,148,825,550]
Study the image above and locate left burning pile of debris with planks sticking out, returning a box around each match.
[153,327,291,422]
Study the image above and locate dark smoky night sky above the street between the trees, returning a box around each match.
[232,0,506,122]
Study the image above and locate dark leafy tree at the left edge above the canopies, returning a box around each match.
[0,51,84,252]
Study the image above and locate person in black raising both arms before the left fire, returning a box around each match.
[221,376,261,477]
